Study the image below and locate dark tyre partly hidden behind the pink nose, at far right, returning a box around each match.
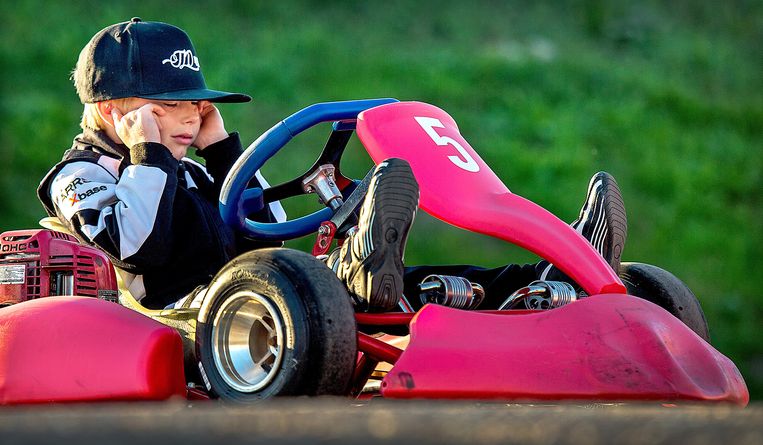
[620,263,710,343]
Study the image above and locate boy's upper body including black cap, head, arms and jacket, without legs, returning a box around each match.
[38,18,282,308]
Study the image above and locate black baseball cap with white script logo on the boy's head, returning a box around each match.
[74,17,252,104]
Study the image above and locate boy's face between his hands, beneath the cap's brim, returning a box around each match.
[123,97,202,159]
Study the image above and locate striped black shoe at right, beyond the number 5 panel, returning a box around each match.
[535,172,628,287]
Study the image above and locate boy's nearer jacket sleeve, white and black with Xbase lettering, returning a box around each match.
[50,146,178,271]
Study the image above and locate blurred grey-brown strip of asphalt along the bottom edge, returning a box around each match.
[0,399,763,445]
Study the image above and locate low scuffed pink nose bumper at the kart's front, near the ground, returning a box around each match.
[381,294,749,406]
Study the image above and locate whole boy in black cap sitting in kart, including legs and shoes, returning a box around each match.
[38,18,626,310]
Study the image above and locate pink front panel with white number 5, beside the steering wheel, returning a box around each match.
[357,102,625,295]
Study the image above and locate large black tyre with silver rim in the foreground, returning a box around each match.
[196,248,357,404]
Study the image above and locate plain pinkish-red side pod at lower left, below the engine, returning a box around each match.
[0,297,186,404]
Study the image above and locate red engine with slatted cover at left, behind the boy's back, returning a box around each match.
[0,230,118,306]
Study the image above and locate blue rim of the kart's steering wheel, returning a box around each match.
[219,99,397,241]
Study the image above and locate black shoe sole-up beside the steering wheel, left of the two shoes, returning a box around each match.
[326,158,419,311]
